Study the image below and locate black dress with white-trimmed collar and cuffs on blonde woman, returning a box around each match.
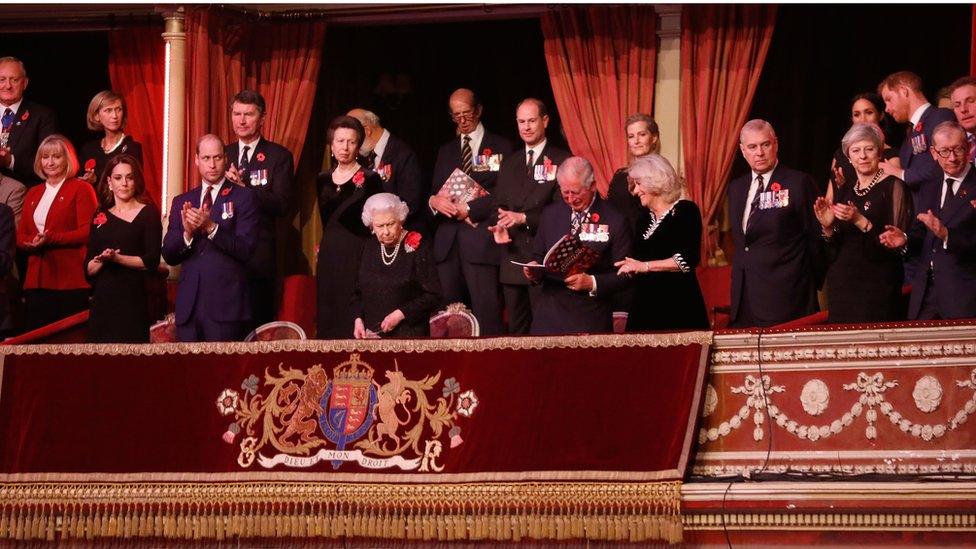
[627,200,708,332]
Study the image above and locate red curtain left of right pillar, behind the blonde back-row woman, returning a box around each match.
[542,6,657,196]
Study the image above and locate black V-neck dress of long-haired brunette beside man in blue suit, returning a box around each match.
[85,204,163,343]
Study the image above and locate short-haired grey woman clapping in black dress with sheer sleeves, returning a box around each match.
[813,123,910,323]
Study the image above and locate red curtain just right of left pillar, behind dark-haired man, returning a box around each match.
[186,8,325,188]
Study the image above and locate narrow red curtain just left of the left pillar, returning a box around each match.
[108,27,165,206]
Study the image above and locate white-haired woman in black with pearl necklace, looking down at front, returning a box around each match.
[353,193,441,339]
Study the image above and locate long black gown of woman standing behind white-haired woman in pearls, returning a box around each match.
[315,170,383,339]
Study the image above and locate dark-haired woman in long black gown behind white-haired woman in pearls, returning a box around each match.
[315,116,383,339]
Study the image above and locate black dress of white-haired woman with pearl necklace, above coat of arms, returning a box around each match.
[355,233,441,337]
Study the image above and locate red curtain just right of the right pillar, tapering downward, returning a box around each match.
[680,4,776,257]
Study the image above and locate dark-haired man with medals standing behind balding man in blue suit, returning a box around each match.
[224,90,295,329]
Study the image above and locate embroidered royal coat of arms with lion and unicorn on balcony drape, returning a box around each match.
[217,353,478,472]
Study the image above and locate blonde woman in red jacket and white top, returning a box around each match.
[17,134,96,330]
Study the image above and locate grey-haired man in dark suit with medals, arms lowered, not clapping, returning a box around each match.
[729,120,823,328]
